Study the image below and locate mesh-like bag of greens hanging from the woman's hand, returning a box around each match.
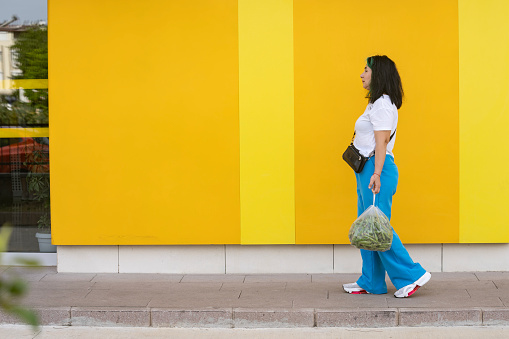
[348,194,392,252]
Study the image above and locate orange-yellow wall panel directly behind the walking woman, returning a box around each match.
[294,0,459,244]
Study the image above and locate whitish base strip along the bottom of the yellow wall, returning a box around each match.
[57,244,509,274]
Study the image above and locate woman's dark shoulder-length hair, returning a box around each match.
[366,55,404,109]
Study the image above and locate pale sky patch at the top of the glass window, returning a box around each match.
[0,0,47,25]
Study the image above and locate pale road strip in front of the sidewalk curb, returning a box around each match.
[0,325,509,339]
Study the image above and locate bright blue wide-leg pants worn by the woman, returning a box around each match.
[355,155,426,294]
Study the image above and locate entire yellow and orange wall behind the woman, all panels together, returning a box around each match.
[45,0,509,245]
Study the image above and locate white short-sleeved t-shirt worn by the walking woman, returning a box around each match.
[353,94,398,157]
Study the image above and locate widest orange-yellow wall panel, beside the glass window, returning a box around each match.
[49,0,240,245]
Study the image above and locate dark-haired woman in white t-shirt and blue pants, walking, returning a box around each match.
[343,55,431,298]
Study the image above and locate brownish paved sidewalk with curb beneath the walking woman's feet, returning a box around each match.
[0,267,509,328]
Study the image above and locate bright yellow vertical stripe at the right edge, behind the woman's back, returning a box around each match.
[459,0,509,243]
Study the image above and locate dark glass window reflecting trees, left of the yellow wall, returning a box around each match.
[0,1,49,252]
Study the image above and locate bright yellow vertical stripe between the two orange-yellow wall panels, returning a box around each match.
[238,0,295,244]
